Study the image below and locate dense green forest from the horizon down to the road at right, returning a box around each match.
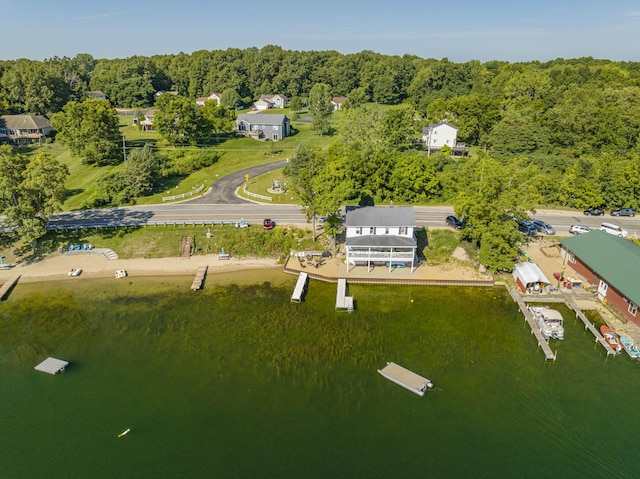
[0,45,640,272]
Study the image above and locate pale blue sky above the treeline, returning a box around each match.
[0,0,640,62]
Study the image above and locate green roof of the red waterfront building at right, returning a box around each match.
[560,230,640,304]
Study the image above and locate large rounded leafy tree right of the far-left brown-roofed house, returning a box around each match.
[51,98,122,165]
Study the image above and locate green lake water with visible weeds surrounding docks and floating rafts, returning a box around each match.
[0,271,640,478]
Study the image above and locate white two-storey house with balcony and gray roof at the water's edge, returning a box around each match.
[346,206,417,272]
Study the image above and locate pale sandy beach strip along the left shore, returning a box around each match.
[0,253,283,283]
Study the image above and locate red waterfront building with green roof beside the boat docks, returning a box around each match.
[560,231,640,326]
